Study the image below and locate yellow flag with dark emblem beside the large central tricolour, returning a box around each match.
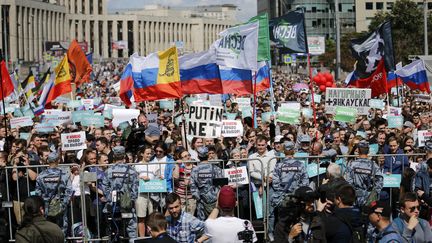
[156,46,180,84]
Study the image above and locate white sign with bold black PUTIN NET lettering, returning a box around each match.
[186,105,223,138]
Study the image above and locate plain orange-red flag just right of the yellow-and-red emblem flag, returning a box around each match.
[67,40,92,87]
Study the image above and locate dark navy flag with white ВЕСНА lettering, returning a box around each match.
[269,11,308,53]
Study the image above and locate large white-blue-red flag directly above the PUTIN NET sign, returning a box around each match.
[179,51,223,94]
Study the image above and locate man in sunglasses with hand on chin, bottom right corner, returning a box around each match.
[393,192,432,243]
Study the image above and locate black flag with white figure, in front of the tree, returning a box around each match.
[351,21,395,78]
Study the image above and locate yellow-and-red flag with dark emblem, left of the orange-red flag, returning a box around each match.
[45,55,72,105]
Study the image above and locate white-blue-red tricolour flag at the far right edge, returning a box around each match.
[396,59,430,93]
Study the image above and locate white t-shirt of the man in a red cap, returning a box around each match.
[205,217,258,243]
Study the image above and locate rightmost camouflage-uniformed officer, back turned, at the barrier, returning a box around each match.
[346,141,384,207]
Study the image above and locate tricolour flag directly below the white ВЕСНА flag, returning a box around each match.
[219,66,253,95]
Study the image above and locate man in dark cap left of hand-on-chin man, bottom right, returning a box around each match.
[365,201,403,243]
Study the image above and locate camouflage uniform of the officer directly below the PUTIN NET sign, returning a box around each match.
[191,163,223,220]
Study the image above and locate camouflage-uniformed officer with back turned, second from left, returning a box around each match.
[102,146,138,239]
